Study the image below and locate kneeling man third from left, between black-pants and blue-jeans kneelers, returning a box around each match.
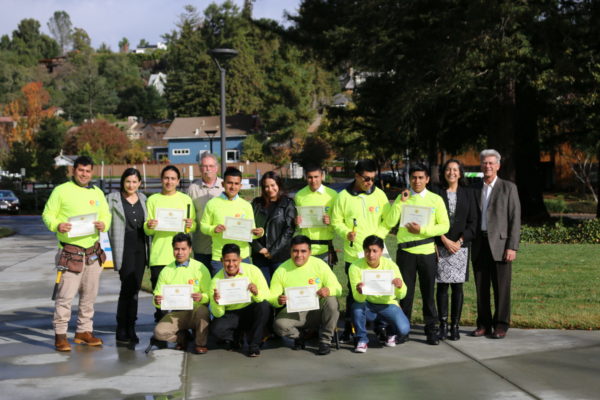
[271,235,342,355]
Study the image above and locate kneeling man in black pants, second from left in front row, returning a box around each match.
[210,243,271,357]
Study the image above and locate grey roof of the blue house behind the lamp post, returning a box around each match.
[164,114,258,140]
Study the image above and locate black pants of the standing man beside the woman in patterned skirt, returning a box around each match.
[396,249,438,331]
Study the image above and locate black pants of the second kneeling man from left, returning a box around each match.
[210,301,272,347]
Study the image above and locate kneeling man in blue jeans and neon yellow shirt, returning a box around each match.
[348,235,410,353]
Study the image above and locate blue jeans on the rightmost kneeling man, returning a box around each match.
[352,301,410,342]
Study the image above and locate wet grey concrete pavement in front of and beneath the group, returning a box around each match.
[0,216,600,399]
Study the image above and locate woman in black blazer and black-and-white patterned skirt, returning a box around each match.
[436,159,477,340]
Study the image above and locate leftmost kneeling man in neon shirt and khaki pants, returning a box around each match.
[154,233,210,354]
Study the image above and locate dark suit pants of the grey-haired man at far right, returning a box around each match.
[473,238,512,331]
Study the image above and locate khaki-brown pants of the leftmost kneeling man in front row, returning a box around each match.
[154,304,209,346]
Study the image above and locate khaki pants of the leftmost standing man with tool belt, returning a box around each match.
[52,249,102,335]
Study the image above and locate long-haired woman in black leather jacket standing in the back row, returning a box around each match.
[252,171,296,284]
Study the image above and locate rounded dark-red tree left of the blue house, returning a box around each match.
[65,120,130,163]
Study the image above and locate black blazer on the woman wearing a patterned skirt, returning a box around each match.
[432,186,478,247]
